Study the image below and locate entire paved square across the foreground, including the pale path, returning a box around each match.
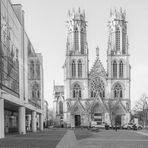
[0,129,148,148]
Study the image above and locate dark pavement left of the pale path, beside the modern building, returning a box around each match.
[0,129,66,148]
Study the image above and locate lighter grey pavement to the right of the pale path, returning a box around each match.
[79,130,148,148]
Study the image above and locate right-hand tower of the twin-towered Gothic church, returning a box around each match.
[107,9,130,124]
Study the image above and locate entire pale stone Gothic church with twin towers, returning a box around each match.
[53,9,130,127]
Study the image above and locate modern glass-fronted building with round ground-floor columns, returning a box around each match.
[0,0,43,138]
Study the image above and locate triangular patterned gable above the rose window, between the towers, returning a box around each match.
[90,55,107,77]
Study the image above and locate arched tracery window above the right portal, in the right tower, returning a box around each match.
[114,83,123,99]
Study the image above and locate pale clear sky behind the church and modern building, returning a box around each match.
[11,0,148,107]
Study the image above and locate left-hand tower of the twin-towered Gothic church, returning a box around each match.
[64,8,89,126]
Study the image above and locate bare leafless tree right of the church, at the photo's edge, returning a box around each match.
[133,94,148,127]
